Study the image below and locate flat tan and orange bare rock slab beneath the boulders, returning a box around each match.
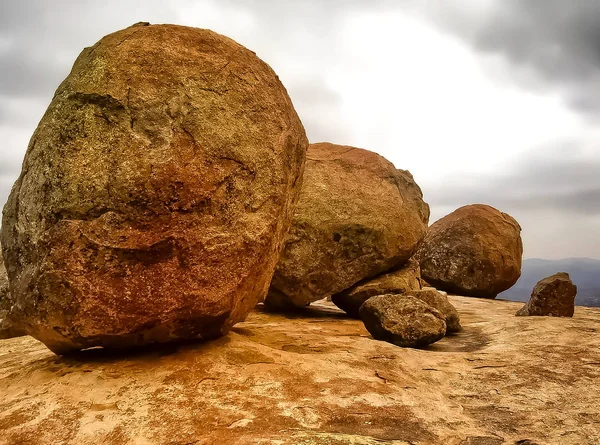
[0,297,600,445]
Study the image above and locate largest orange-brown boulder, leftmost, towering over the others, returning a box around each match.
[2,23,308,353]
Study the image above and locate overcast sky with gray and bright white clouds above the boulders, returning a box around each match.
[0,0,600,258]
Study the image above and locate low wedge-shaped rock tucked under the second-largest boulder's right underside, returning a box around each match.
[331,261,421,318]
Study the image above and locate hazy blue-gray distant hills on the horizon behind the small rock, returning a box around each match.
[498,258,600,307]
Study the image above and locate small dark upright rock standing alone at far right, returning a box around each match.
[516,272,577,317]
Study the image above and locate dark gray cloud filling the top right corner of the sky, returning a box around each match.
[437,0,600,118]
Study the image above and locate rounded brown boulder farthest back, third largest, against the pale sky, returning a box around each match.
[417,204,523,298]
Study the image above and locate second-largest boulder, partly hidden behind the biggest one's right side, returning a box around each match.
[267,143,429,306]
